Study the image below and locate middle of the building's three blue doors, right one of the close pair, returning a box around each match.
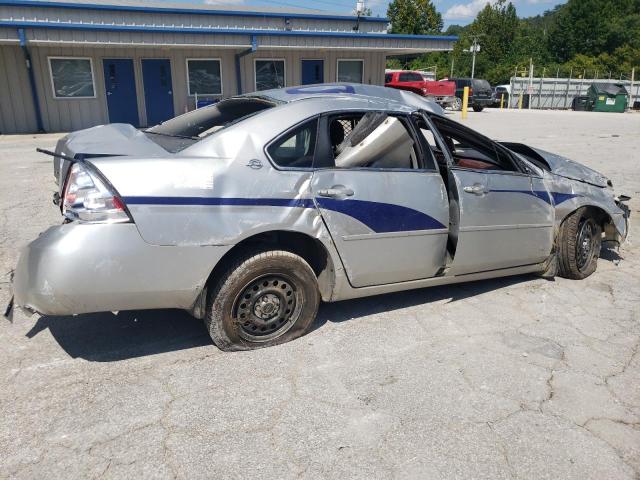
[142,58,174,126]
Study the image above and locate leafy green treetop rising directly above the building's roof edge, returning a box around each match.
[387,0,444,35]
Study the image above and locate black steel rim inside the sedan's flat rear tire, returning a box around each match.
[233,274,304,342]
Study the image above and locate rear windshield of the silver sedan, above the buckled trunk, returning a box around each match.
[144,97,275,153]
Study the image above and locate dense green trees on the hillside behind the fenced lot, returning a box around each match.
[388,0,640,85]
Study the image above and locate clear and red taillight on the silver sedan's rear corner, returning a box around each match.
[62,163,131,223]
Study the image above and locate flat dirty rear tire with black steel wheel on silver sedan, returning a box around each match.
[204,250,320,351]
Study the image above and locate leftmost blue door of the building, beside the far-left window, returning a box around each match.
[102,58,140,127]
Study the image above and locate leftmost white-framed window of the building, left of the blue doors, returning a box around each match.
[49,57,96,98]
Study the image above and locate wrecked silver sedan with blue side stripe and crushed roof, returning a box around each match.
[8,84,629,350]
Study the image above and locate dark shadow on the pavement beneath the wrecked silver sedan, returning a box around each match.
[26,275,535,362]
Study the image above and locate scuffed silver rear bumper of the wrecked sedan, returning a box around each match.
[13,223,231,315]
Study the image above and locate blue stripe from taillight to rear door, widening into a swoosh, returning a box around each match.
[123,197,447,233]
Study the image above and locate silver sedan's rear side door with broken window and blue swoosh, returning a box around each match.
[311,112,448,287]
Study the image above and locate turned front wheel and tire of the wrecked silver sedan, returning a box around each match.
[558,208,602,280]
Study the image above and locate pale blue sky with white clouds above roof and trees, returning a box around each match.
[184,0,565,28]
